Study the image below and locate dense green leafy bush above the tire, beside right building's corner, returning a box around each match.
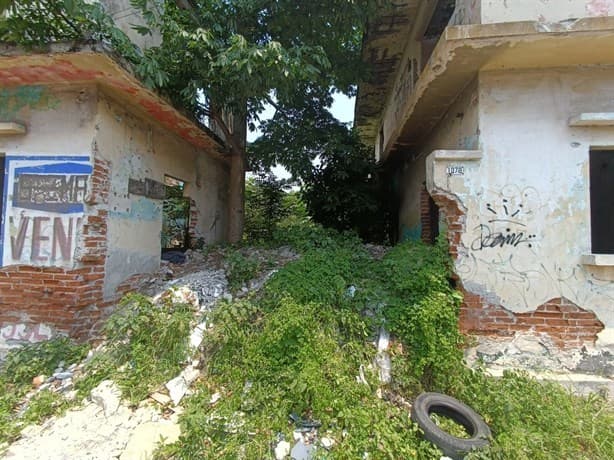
[380,239,463,390]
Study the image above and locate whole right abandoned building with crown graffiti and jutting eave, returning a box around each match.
[356,0,614,348]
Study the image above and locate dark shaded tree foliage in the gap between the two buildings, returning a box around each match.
[248,103,392,242]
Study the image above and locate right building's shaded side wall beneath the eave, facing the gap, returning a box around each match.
[399,79,480,240]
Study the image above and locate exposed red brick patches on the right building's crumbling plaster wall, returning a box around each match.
[432,192,603,348]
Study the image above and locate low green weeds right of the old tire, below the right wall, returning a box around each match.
[460,369,614,460]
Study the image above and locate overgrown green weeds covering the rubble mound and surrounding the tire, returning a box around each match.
[159,230,614,459]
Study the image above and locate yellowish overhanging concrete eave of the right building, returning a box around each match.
[377,17,614,160]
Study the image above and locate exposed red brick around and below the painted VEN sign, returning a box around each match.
[0,159,110,339]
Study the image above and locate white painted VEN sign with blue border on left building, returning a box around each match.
[2,156,92,266]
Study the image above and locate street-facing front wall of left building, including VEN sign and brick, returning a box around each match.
[0,85,107,344]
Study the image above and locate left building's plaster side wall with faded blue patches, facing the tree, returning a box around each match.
[95,96,228,296]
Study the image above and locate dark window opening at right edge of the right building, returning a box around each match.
[589,150,614,254]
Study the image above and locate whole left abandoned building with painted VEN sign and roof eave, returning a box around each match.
[0,44,229,344]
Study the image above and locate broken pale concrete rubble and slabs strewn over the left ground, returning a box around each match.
[0,248,306,460]
